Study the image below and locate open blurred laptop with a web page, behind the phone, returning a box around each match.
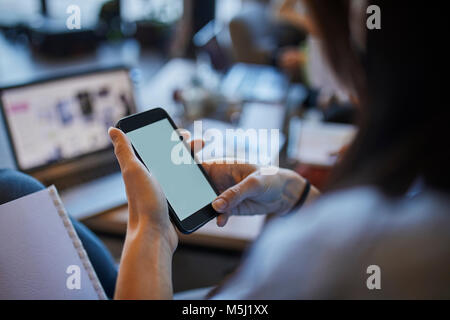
[0,66,136,219]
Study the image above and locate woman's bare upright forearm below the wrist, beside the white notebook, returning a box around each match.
[114,231,173,299]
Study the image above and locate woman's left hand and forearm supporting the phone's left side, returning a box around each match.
[108,128,207,299]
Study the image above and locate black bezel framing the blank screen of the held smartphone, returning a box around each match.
[116,108,219,234]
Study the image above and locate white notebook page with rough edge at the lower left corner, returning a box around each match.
[0,186,106,300]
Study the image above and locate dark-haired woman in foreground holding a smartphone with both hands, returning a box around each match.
[109,0,444,299]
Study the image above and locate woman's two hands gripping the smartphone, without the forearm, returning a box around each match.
[109,128,318,238]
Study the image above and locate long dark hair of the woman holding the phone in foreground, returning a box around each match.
[306,0,442,196]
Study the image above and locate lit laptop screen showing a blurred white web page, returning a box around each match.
[0,69,135,170]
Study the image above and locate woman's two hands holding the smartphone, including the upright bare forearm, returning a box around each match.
[109,128,318,299]
